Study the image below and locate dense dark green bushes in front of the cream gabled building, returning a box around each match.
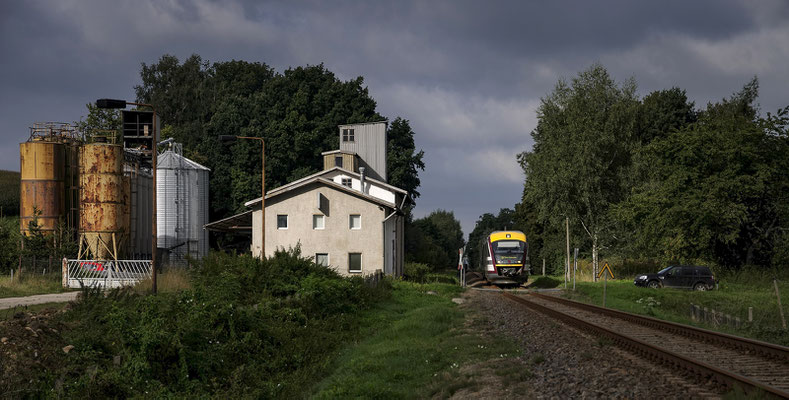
[43,249,386,398]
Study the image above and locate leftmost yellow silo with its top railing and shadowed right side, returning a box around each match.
[19,122,79,235]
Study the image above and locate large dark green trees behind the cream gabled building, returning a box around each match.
[135,55,424,222]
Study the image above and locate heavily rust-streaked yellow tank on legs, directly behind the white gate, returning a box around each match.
[79,137,128,260]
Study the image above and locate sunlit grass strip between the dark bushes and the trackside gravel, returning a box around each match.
[312,277,524,399]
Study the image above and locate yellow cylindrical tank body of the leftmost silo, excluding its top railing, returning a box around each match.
[19,136,66,235]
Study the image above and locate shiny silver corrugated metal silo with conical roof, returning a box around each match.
[156,144,210,265]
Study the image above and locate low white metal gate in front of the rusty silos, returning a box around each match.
[63,258,151,289]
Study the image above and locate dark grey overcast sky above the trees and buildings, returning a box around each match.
[0,0,789,234]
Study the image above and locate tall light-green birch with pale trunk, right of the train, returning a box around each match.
[519,65,639,278]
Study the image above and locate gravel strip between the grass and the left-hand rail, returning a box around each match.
[464,290,720,399]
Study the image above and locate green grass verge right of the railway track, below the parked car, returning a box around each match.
[542,271,789,345]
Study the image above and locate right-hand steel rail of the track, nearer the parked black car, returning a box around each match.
[533,293,789,363]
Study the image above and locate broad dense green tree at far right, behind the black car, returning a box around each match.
[617,79,789,267]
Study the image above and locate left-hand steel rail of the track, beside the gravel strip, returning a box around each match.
[502,293,789,399]
